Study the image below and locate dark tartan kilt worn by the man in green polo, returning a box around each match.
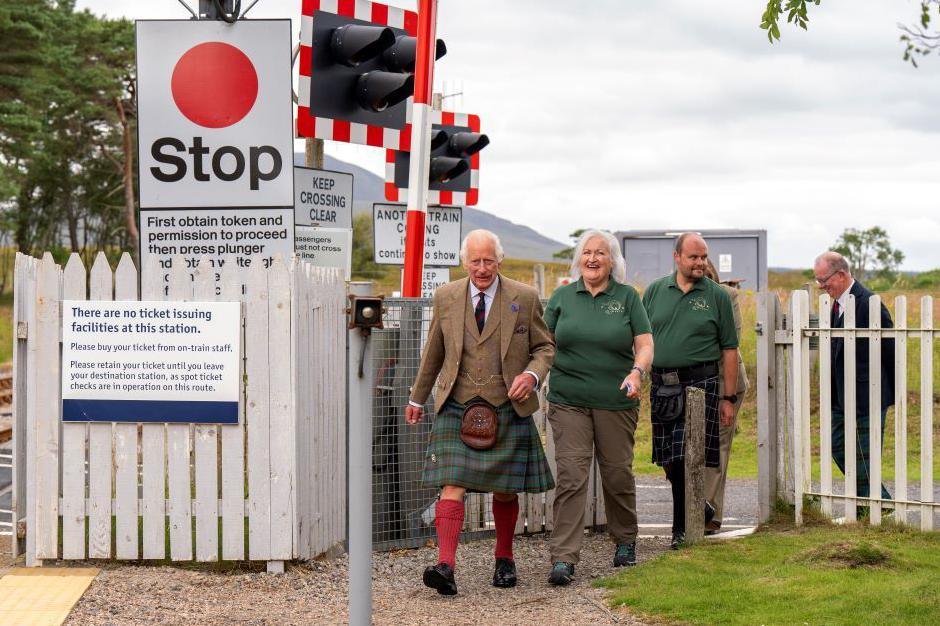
[650,376,721,467]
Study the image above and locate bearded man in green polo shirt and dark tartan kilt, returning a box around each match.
[643,233,738,549]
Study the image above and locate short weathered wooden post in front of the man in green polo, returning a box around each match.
[685,387,705,544]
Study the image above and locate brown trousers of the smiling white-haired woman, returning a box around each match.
[548,403,640,563]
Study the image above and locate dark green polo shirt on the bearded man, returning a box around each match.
[643,273,738,368]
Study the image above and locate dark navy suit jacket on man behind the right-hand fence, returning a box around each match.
[829,280,894,417]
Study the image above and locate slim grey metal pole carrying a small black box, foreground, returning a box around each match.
[346,282,375,626]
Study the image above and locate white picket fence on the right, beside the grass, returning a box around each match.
[758,291,940,530]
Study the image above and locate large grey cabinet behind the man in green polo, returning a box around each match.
[615,230,767,291]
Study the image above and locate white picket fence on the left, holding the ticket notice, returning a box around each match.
[13,254,346,565]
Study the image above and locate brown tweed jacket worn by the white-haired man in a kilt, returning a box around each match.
[410,275,555,417]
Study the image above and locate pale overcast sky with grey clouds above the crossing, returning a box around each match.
[78,0,940,270]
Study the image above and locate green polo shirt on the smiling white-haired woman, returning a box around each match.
[545,279,651,410]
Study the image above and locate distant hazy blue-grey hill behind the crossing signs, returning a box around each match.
[294,152,568,262]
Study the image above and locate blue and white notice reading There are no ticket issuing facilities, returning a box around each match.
[62,300,241,424]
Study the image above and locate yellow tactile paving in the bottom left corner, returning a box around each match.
[0,567,98,626]
